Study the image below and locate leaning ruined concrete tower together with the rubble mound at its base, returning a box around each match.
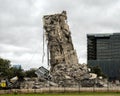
[40,11,106,86]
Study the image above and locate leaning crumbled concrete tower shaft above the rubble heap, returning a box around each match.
[43,11,78,70]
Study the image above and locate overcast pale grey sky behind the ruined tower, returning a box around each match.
[0,0,120,70]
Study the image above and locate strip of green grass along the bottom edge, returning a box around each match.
[0,92,120,96]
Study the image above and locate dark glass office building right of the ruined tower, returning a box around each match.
[87,33,120,80]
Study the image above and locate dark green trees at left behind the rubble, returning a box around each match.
[0,57,36,79]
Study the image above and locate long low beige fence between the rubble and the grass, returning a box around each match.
[0,86,120,94]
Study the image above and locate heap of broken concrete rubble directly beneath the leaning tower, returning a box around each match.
[52,64,91,87]
